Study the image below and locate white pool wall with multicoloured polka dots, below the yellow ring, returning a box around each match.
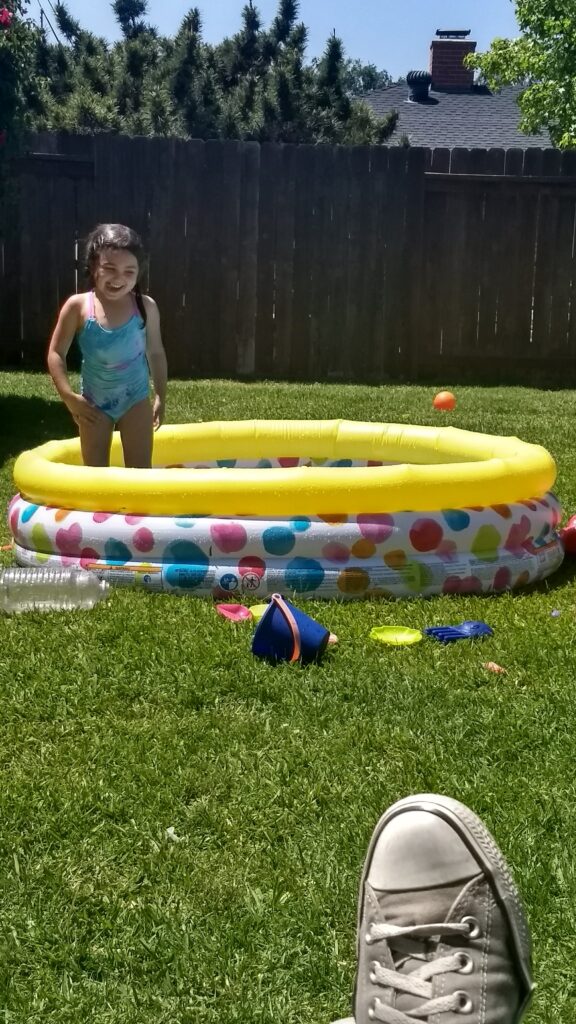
[8,495,564,598]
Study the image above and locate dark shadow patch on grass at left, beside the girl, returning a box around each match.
[0,394,76,465]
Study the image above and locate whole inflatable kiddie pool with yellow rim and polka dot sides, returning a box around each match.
[9,420,563,598]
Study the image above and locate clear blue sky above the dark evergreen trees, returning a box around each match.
[30,0,518,78]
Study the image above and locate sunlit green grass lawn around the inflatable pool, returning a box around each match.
[0,374,576,1024]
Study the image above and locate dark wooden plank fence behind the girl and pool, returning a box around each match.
[0,135,576,384]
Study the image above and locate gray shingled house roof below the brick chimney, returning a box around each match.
[361,82,552,150]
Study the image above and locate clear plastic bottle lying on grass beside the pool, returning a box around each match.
[0,568,109,615]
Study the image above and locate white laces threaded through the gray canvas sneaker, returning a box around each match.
[366,921,472,1024]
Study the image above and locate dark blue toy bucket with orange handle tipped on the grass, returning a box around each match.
[252,594,330,664]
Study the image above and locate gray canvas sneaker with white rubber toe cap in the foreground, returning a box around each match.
[334,794,533,1024]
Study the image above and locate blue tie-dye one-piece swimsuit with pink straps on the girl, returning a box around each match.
[78,292,150,423]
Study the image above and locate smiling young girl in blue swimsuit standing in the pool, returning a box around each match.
[48,224,166,468]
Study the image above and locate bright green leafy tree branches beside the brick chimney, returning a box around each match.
[468,0,576,148]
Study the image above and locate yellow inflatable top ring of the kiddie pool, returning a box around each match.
[14,420,556,516]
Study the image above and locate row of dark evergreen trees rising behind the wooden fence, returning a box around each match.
[25,0,394,143]
